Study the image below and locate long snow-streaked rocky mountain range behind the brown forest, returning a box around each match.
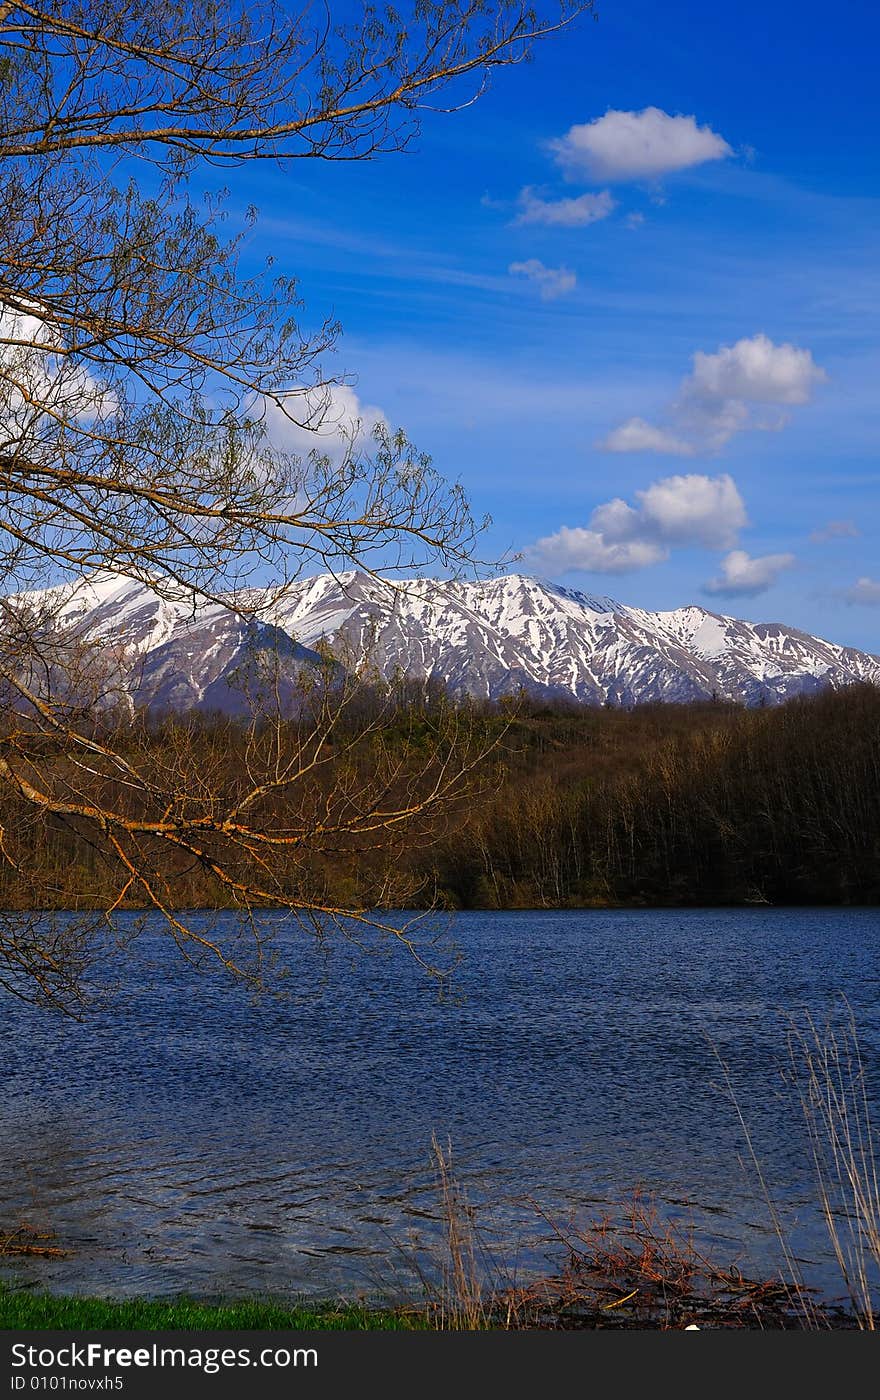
[3,573,880,711]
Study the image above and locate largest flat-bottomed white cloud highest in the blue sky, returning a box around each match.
[550,106,733,181]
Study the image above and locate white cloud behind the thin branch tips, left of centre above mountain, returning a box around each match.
[257,384,388,462]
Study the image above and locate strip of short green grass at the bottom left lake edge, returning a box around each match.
[0,1284,431,1331]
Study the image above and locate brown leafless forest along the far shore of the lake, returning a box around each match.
[0,685,880,910]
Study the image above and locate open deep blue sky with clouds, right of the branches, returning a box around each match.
[229,0,880,651]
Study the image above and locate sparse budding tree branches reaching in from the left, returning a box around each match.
[0,0,592,1008]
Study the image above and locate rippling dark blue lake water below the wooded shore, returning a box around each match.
[0,907,880,1296]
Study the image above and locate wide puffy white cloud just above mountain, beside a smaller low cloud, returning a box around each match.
[525,473,747,574]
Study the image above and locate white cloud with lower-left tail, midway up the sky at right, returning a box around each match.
[599,333,827,456]
